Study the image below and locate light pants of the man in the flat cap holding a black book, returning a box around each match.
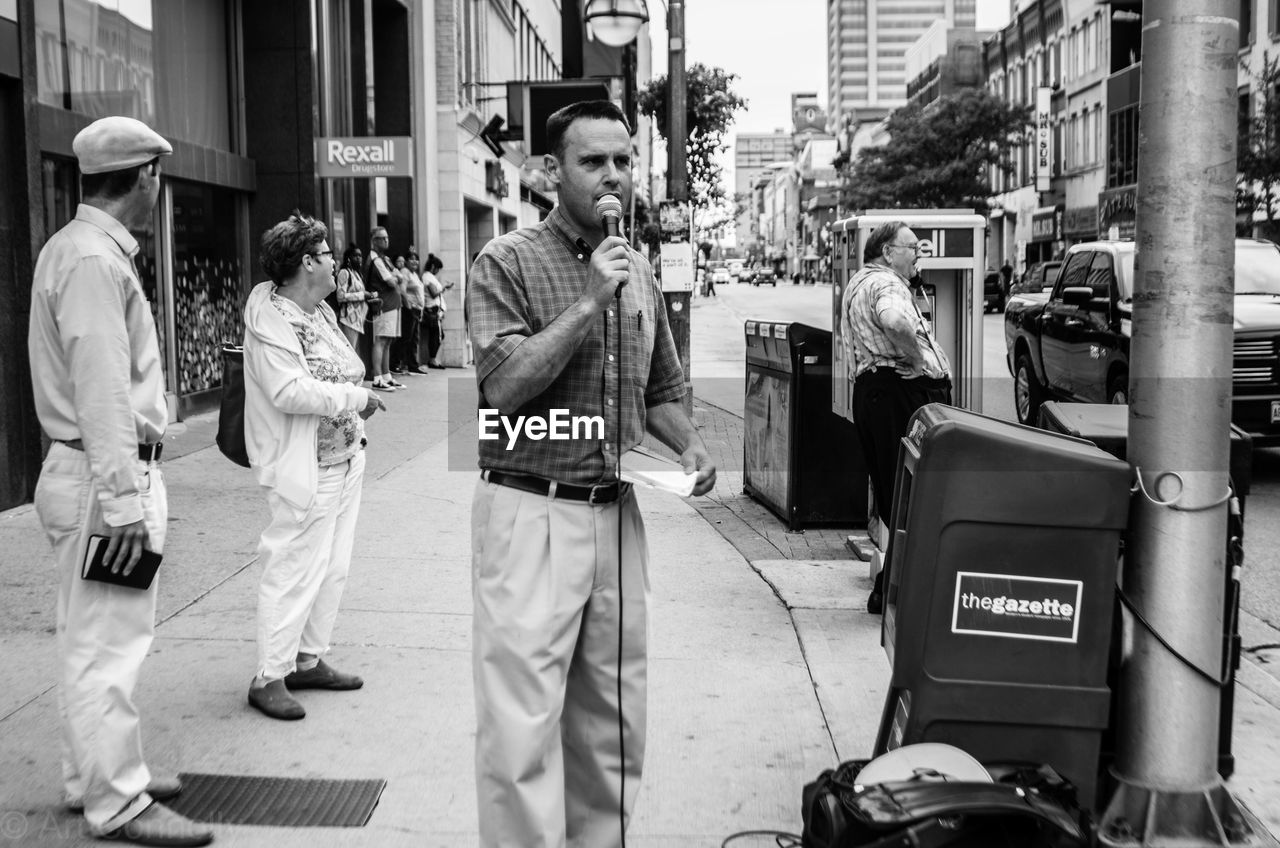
[36,442,169,834]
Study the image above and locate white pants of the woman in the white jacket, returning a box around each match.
[257,451,365,680]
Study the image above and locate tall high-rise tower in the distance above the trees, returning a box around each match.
[827,0,977,128]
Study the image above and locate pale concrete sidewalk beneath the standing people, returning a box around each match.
[0,348,1280,848]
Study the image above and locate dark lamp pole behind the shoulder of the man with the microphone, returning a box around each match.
[663,0,696,414]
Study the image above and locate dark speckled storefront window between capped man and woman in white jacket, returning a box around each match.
[172,181,244,396]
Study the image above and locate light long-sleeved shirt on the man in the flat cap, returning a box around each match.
[27,204,169,526]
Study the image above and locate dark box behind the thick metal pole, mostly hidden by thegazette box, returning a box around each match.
[1039,401,1253,780]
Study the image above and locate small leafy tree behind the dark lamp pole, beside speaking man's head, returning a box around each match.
[639,63,746,216]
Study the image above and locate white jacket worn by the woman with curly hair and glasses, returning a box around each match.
[244,281,369,520]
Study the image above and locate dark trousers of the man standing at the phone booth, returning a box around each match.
[854,368,951,529]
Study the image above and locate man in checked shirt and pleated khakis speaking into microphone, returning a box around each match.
[467,101,716,848]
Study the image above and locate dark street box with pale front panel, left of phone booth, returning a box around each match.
[742,322,868,530]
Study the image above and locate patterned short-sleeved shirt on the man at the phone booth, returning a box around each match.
[840,263,951,379]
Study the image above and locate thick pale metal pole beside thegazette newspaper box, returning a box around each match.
[1098,0,1252,847]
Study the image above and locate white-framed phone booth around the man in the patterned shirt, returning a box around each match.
[831,209,987,420]
